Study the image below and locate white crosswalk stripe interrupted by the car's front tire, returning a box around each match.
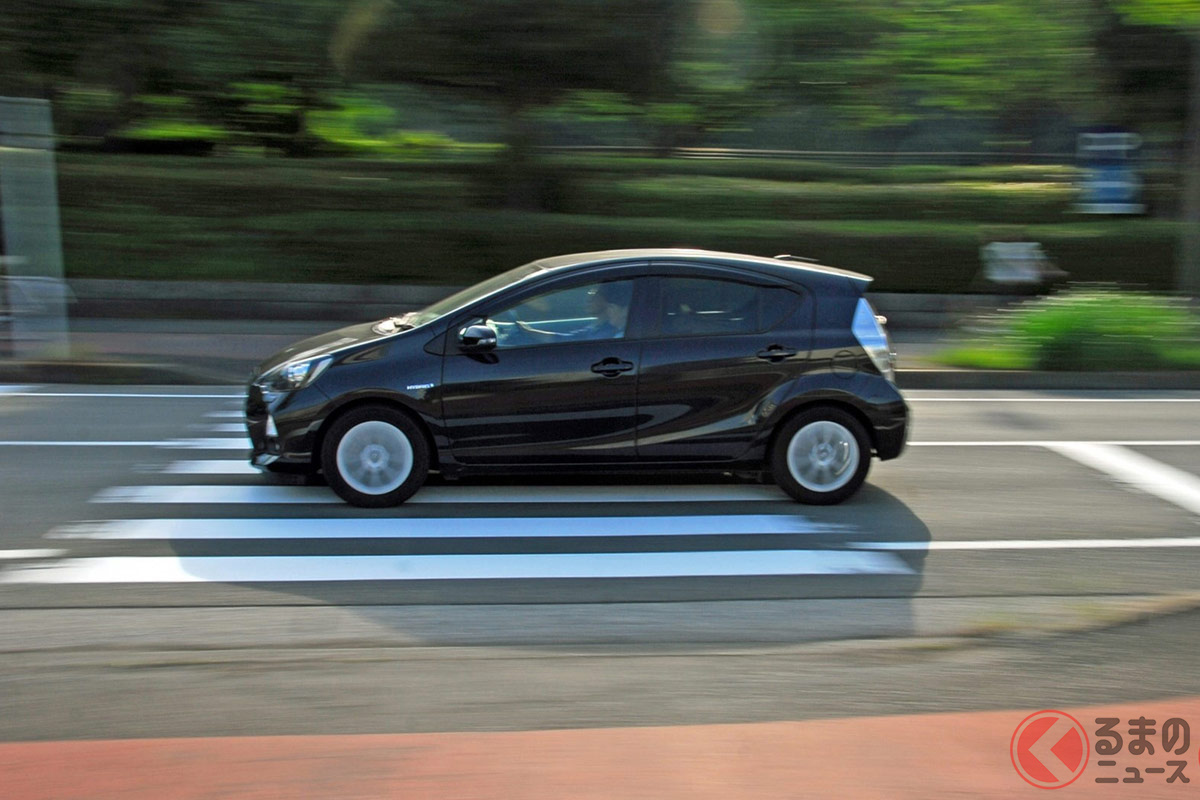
[91,485,792,505]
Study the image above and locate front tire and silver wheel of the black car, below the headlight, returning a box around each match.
[320,405,430,509]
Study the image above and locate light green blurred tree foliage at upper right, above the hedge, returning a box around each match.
[754,0,1096,146]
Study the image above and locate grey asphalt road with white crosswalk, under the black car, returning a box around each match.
[0,386,1200,739]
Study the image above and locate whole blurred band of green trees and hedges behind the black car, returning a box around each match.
[0,0,1200,299]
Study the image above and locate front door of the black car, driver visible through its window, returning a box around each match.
[442,270,641,464]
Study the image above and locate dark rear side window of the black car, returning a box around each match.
[659,278,800,336]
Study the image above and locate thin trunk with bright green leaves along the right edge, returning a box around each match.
[1118,0,1200,295]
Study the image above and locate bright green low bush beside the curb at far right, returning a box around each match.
[942,285,1200,372]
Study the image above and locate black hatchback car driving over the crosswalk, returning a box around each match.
[246,249,908,506]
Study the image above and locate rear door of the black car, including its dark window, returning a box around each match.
[637,272,812,462]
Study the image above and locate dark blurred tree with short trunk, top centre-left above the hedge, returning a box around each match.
[334,0,690,184]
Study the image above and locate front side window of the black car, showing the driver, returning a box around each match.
[485,281,634,348]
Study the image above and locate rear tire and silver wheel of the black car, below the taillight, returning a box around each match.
[770,408,871,505]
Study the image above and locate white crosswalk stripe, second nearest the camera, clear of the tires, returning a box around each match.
[46,515,853,541]
